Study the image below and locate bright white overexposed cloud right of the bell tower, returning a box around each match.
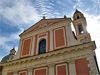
[84,13,100,67]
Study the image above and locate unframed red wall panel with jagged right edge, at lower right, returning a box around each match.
[75,58,90,75]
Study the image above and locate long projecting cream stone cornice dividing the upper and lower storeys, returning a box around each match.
[0,41,96,66]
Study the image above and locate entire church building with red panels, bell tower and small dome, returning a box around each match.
[0,9,99,75]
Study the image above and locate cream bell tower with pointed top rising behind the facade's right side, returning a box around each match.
[73,9,91,43]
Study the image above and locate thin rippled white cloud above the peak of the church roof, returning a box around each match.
[35,0,57,18]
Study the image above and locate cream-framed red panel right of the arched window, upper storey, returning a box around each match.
[53,27,67,49]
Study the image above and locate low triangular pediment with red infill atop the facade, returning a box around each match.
[20,18,68,35]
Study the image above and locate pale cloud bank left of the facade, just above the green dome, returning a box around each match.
[0,29,23,55]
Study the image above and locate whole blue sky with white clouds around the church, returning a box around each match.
[0,0,100,67]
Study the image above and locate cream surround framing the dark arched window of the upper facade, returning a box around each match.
[36,32,48,54]
